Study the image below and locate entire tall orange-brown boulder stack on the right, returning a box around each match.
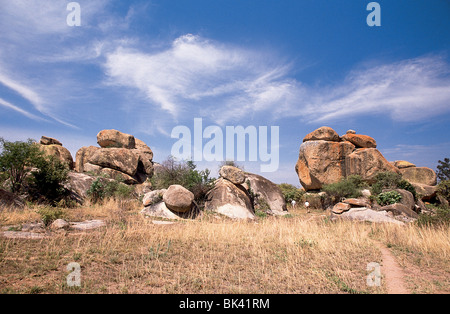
[295,127,400,191]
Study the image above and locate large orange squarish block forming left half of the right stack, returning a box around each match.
[295,140,355,191]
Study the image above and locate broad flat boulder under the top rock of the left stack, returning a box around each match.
[88,148,139,177]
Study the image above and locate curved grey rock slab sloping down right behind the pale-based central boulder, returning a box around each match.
[246,173,287,215]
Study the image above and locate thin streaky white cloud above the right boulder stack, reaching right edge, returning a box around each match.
[304,56,450,122]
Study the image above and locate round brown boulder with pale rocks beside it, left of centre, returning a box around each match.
[142,185,199,219]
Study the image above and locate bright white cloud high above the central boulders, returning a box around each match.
[105,34,296,122]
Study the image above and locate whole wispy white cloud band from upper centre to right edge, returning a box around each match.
[105,34,450,130]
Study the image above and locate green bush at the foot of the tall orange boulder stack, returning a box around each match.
[322,175,365,202]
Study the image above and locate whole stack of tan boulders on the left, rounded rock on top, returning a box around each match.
[75,130,153,185]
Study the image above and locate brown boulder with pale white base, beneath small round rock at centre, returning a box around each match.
[205,178,255,219]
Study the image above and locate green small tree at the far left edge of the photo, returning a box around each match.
[0,138,43,193]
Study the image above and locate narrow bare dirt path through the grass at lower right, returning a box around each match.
[375,241,410,294]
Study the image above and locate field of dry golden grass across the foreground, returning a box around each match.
[0,201,450,294]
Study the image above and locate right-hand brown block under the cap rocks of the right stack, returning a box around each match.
[345,148,399,182]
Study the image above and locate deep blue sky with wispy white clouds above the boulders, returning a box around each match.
[0,0,450,185]
